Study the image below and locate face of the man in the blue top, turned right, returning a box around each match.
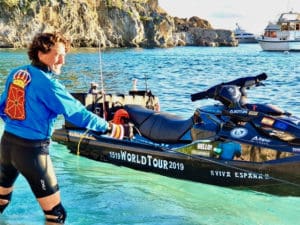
[38,42,66,74]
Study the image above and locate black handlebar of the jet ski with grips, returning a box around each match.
[191,73,268,102]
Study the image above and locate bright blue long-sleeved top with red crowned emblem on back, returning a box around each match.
[0,65,108,140]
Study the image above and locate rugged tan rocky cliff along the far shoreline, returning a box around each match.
[0,0,237,48]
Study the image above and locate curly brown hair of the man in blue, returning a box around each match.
[28,32,70,63]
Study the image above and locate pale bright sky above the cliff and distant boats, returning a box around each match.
[158,0,300,34]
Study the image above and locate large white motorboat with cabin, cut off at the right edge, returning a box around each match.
[257,12,300,51]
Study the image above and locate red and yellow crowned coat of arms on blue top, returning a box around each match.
[4,70,31,120]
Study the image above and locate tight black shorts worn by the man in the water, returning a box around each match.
[0,132,58,198]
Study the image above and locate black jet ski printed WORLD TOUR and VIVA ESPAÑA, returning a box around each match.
[53,73,300,196]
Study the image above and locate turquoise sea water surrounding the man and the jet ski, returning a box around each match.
[0,44,300,225]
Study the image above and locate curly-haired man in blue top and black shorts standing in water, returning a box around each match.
[0,33,120,224]
